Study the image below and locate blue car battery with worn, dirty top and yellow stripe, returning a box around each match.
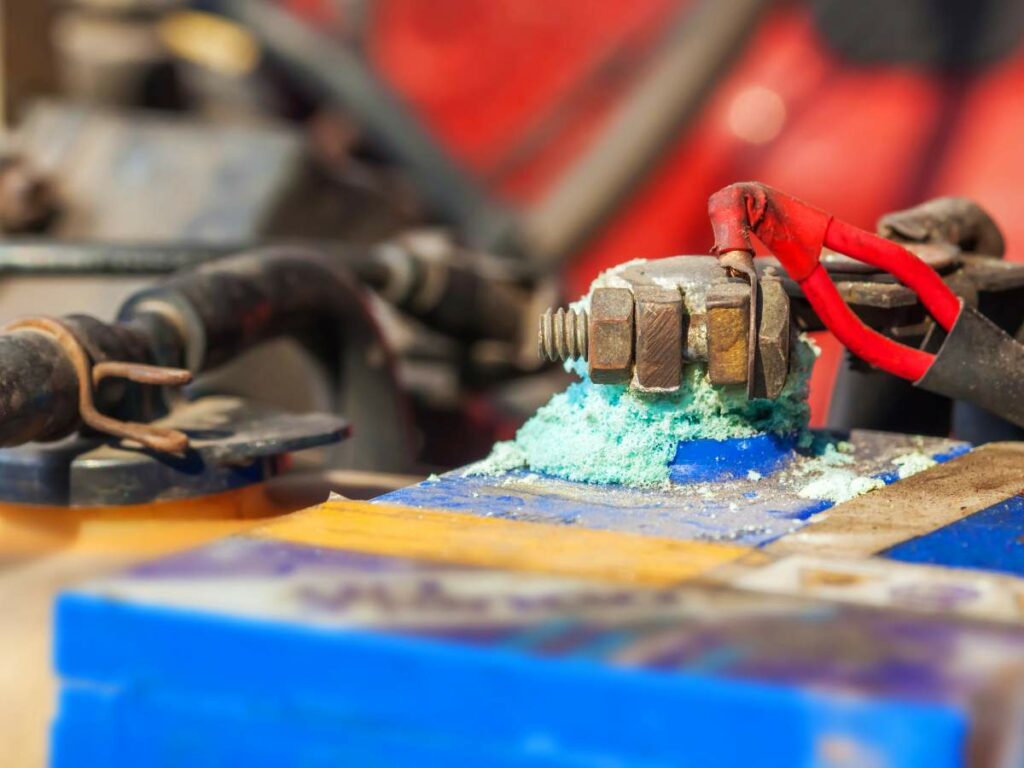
[53,432,1024,768]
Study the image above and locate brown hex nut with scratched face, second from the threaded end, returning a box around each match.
[633,286,683,392]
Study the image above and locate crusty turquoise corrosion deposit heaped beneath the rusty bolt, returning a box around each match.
[469,329,817,486]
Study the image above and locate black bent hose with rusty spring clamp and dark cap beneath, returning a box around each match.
[0,247,415,504]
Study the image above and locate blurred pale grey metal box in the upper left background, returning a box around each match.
[18,102,304,244]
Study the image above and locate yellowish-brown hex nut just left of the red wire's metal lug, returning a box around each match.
[705,282,751,386]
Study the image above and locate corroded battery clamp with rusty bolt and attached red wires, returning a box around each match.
[540,182,1024,426]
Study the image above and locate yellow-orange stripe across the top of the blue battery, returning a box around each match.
[256,501,750,587]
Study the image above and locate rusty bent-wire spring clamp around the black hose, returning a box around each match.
[3,316,191,454]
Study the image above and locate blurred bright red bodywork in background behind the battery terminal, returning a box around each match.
[289,0,1024,424]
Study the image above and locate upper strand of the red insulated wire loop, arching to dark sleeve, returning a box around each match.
[824,219,961,331]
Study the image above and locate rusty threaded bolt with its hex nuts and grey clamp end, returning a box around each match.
[539,256,791,398]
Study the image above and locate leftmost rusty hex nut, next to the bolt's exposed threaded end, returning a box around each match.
[588,288,633,384]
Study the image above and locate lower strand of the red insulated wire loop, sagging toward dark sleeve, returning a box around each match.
[800,266,937,381]
